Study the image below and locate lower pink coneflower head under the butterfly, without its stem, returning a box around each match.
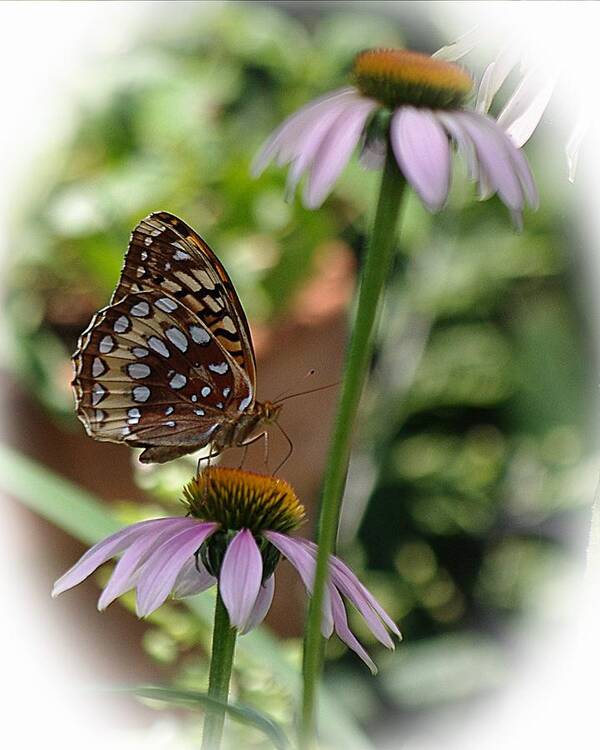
[52,468,400,672]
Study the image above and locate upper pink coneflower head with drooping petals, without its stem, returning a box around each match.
[252,50,538,224]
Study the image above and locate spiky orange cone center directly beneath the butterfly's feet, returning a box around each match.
[183,467,304,535]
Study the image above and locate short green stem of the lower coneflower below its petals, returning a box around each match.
[202,592,237,750]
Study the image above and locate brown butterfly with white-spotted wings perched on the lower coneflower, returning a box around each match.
[71,211,281,463]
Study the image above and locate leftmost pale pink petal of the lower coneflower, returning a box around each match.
[52,518,191,596]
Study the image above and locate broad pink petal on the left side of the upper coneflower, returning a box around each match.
[304,97,377,208]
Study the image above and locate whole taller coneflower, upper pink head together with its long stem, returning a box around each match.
[253,44,538,748]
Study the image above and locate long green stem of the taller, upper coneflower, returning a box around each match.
[300,145,406,748]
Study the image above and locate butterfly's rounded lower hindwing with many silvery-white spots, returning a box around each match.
[73,290,253,461]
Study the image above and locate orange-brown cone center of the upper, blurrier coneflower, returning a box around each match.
[352,49,473,109]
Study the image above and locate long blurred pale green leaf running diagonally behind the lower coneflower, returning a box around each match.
[0,445,373,750]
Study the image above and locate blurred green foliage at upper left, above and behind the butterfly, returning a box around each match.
[8,3,400,413]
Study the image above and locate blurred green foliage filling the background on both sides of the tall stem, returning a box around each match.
[7,3,595,748]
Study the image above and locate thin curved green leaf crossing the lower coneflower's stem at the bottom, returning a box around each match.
[115,685,290,750]
